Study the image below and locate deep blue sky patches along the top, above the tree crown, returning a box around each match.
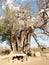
[0,0,38,16]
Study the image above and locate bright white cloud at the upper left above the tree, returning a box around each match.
[2,0,20,11]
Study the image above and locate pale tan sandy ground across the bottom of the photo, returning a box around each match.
[0,55,49,65]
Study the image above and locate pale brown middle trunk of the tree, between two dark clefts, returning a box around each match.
[16,30,25,53]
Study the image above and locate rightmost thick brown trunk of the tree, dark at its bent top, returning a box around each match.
[24,27,32,53]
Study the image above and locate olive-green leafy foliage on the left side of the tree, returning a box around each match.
[0,5,19,41]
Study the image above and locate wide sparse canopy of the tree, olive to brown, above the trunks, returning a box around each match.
[0,0,49,52]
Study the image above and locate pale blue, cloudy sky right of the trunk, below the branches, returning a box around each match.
[30,28,49,47]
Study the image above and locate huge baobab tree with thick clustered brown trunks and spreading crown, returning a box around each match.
[0,0,49,52]
